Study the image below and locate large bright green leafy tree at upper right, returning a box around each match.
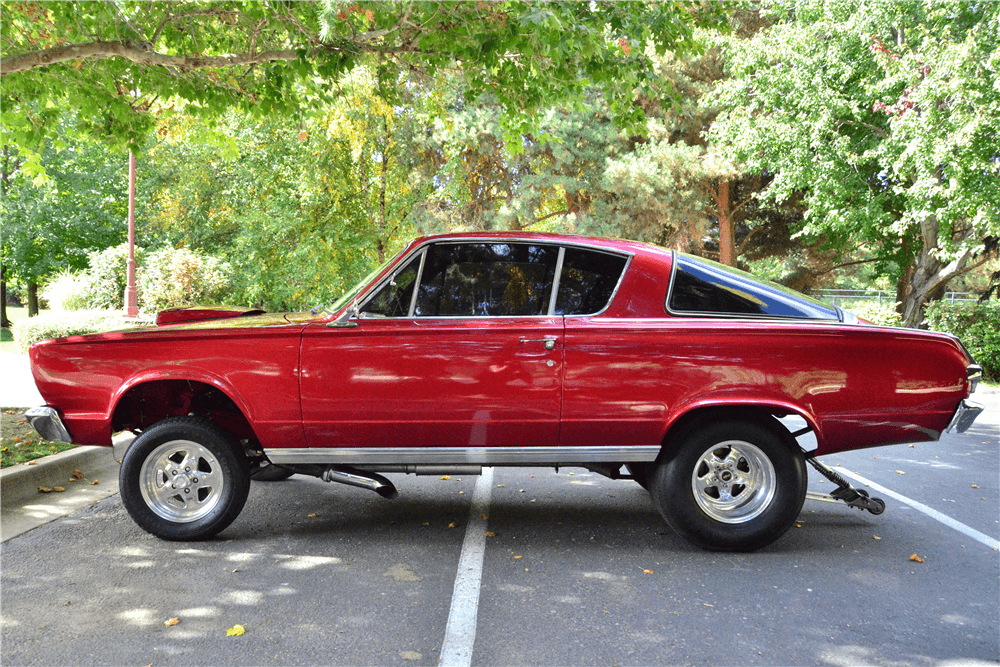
[712,0,1000,326]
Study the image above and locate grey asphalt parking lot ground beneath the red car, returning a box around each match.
[0,395,1000,666]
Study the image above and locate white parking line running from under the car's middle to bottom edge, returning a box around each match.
[438,468,493,667]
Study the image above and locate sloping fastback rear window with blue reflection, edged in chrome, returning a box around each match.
[667,253,840,320]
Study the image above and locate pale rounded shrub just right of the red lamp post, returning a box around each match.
[139,248,232,312]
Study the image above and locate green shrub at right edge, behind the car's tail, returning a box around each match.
[926,300,1000,382]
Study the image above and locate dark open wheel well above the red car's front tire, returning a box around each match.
[111,380,256,440]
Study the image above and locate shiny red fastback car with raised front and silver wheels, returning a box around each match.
[28,233,982,551]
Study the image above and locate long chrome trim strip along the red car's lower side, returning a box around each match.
[264,445,660,466]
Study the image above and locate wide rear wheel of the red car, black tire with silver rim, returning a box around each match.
[649,421,807,551]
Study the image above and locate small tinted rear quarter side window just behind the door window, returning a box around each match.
[555,248,628,315]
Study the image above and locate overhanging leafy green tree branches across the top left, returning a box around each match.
[0,0,720,152]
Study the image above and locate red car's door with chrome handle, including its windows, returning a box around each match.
[300,240,563,449]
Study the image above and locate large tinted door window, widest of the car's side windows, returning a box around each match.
[414,243,559,317]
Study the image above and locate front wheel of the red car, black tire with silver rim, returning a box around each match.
[118,417,250,541]
